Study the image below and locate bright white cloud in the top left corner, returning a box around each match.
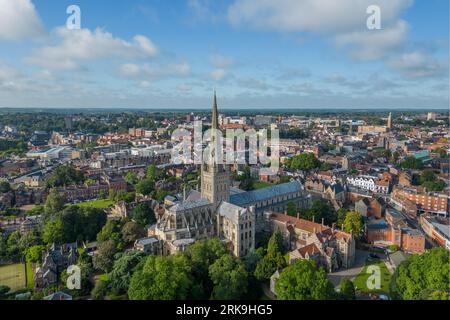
[0,0,44,40]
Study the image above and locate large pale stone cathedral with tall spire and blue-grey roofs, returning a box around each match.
[153,94,311,257]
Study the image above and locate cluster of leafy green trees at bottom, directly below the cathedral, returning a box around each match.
[124,239,249,300]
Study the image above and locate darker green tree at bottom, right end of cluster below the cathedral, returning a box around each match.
[209,254,248,300]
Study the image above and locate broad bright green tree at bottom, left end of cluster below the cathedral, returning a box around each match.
[128,255,192,300]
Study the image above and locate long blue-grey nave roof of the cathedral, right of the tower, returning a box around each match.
[230,181,303,206]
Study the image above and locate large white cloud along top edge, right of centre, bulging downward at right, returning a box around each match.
[228,0,413,60]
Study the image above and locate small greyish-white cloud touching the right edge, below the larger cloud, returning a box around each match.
[387,51,448,79]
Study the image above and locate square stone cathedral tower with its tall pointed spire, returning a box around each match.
[201,92,231,206]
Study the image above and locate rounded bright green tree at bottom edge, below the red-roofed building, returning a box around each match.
[275,260,334,300]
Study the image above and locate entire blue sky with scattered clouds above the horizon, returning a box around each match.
[0,0,449,109]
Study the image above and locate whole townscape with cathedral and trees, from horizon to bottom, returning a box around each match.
[0,96,450,300]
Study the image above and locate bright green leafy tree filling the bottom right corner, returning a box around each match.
[390,248,450,300]
